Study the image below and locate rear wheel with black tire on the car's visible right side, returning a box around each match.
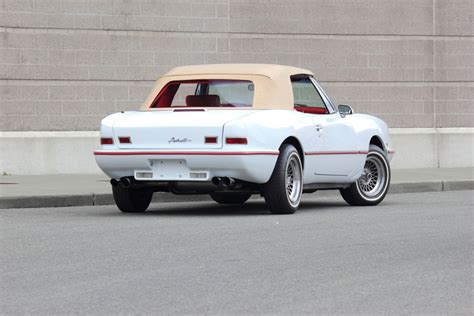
[263,144,303,214]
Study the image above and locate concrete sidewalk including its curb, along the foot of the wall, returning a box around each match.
[0,168,474,209]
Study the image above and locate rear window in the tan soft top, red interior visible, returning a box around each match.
[150,80,254,108]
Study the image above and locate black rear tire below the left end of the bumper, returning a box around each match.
[112,185,153,213]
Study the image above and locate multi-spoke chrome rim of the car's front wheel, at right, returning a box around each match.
[356,153,387,199]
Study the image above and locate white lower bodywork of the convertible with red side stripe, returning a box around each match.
[95,109,391,184]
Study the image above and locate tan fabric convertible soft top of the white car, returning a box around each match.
[141,64,313,110]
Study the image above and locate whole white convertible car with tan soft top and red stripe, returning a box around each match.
[94,64,393,214]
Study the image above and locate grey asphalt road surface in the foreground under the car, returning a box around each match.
[0,191,474,314]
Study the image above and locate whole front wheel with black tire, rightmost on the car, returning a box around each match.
[340,145,391,206]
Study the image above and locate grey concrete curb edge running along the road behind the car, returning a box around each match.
[0,180,474,209]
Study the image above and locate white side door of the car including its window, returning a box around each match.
[292,76,358,183]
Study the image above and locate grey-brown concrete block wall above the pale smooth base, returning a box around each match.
[0,0,474,131]
